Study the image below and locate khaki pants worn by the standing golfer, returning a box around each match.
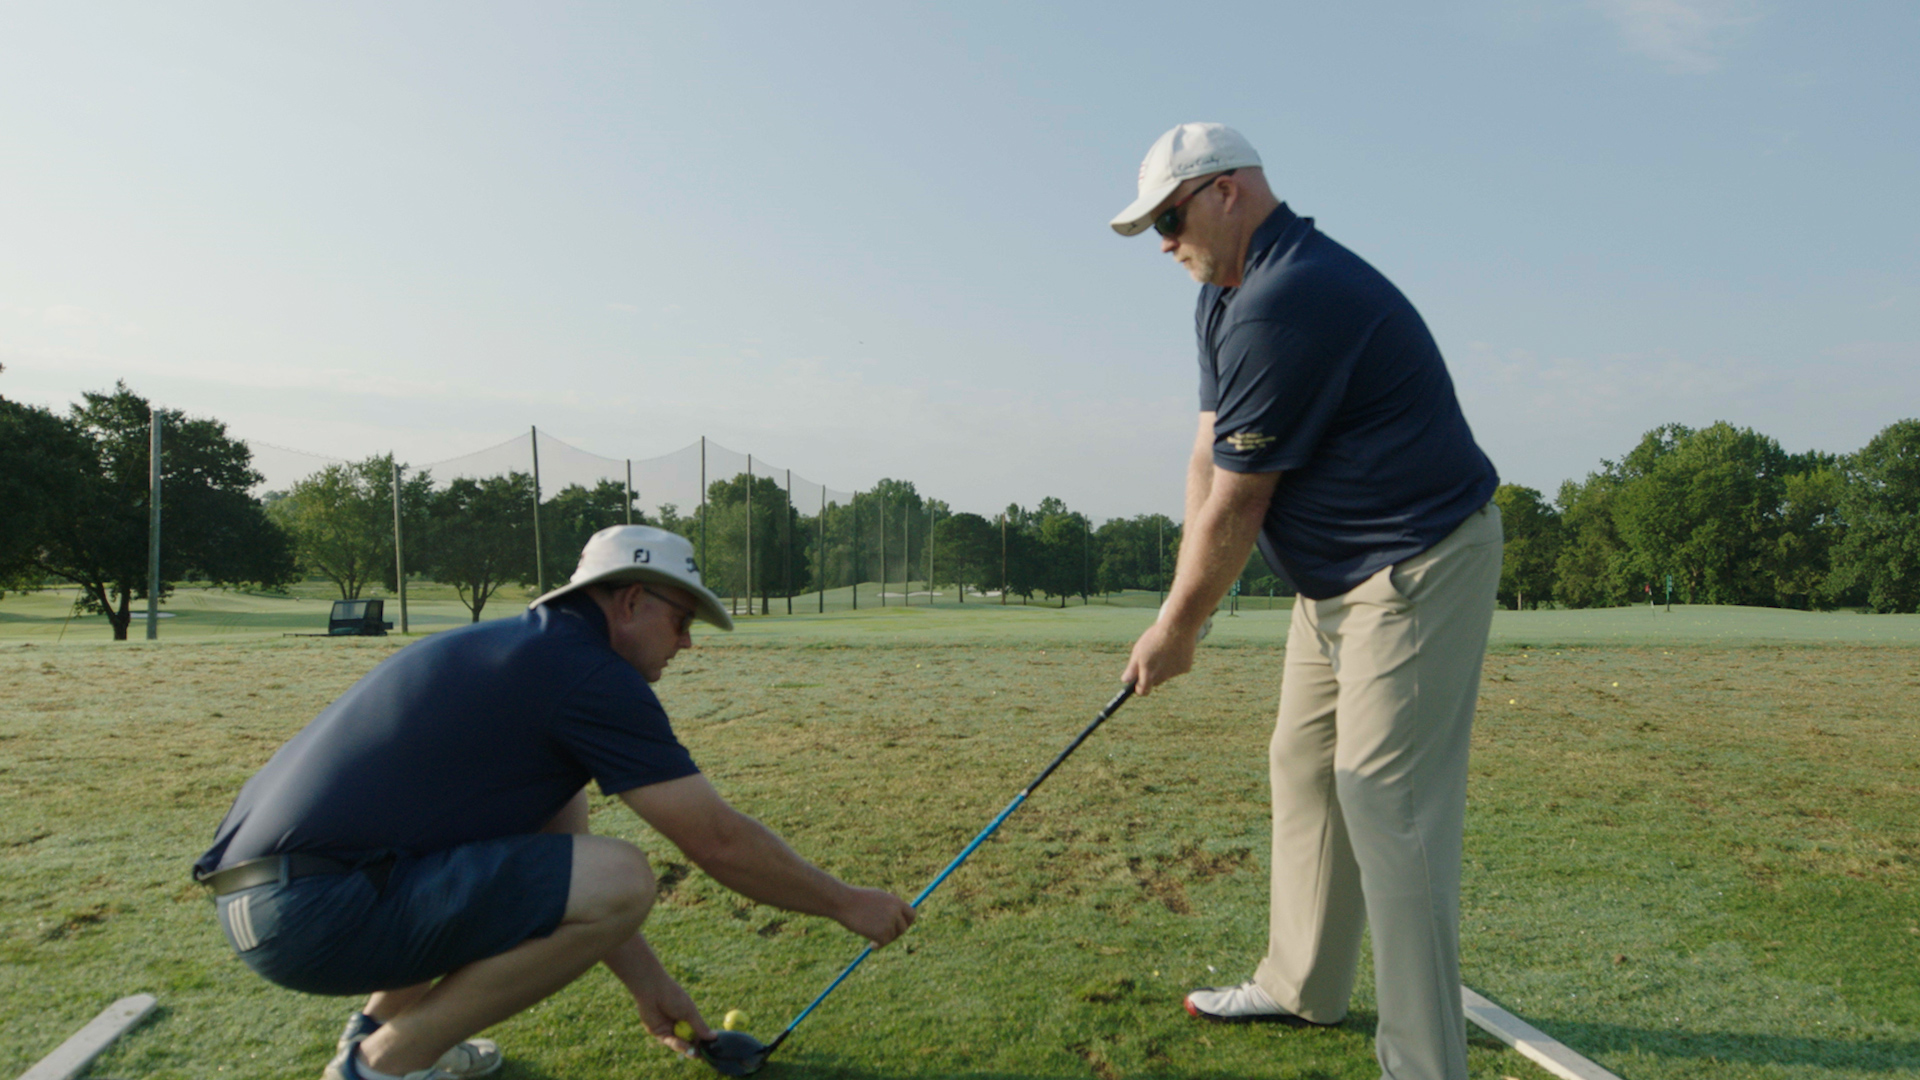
[1254,503,1501,1080]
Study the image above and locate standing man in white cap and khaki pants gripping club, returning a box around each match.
[1112,123,1501,1080]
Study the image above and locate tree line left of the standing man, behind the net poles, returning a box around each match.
[0,382,1213,640]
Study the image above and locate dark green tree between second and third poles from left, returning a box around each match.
[420,473,540,623]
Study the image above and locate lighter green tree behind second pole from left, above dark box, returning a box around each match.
[272,455,434,600]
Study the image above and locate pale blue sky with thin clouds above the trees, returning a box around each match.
[0,0,1920,519]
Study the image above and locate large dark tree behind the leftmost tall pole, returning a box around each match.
[20,382,298,642]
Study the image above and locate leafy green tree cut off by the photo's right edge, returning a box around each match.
[1828,419,1920,611]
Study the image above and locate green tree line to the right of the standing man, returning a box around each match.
[1494,419,1920,611]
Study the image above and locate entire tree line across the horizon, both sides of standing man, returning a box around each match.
[0,376,1920,640]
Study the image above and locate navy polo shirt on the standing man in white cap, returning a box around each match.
[1194,204,1500,600]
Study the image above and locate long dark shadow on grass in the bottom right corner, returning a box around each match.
[1534,1020,1920,1074]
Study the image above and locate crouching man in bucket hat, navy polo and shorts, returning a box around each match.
[194,525,914,1080]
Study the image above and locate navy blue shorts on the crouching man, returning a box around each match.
[215,832,574,994]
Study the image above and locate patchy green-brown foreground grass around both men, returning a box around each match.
[0,640,1920,1080]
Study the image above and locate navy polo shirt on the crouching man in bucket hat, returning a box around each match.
[194,594,699,872]
